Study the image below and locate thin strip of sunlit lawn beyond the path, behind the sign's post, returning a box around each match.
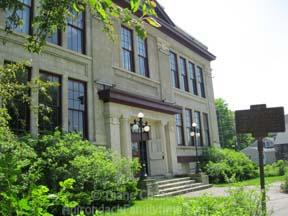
[213,176,284,187]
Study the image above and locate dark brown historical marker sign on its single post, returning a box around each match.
[235,104,285,213]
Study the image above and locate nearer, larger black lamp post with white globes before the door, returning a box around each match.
[132,112,150,179]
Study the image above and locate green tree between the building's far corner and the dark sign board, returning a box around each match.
[215,98,253,150]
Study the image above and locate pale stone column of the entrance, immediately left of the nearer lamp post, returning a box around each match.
[120,116,132,159]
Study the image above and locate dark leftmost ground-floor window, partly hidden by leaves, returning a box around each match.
[5,62,31,134]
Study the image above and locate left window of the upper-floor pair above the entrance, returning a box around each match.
[121,26,134,71]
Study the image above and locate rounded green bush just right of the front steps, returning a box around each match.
[203,148,258,183]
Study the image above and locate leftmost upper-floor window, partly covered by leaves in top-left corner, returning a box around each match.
[6,0,33,34]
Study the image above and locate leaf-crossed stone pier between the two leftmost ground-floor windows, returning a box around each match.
[30,63,39,136]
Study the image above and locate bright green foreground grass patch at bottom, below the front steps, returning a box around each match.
[101,197,187,216]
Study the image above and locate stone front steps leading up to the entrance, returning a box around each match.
[155,177,212,197]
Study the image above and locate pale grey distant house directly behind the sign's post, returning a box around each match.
[242,137,276,164]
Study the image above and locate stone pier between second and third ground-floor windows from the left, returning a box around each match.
[61,74,69,132]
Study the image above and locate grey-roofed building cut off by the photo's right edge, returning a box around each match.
[275,115,288,160]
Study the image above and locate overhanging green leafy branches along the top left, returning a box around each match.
[0,0,160,53]
